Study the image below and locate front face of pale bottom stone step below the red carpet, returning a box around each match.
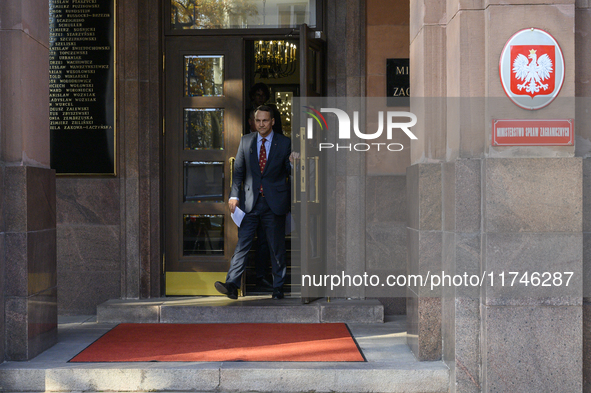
[0,362,449,393]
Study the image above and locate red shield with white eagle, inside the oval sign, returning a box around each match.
[511,45,556,98]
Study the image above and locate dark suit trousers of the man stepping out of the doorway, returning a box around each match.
[226,195,287,288]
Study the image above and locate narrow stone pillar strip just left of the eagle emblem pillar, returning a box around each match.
[406,0,447,360]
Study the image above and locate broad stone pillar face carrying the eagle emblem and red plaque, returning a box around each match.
[481,1,583,392]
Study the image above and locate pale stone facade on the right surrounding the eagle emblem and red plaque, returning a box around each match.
[407,1,590,392]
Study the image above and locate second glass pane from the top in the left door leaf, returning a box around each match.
[185,110,224,149]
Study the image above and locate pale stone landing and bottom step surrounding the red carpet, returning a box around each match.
[0,316,449,393]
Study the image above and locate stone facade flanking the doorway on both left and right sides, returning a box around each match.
[0,0,591,392]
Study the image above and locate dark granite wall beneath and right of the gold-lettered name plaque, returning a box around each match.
[57,0,162,314]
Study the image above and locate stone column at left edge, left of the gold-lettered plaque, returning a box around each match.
[0,0,57,360]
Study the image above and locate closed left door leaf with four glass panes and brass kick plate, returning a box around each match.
[164,36,244,296]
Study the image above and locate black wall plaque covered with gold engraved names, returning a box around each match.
[49,0,116,175]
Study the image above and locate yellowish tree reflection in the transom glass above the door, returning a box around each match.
[170,0,258,29]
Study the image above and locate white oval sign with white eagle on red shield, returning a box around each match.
[499,27,564,110]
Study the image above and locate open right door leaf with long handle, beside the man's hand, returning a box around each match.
[293,24,326,303]
